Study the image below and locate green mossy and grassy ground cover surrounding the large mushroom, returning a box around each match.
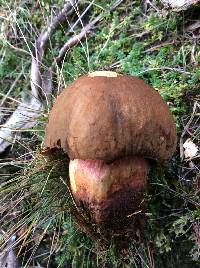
[0,0,200,268]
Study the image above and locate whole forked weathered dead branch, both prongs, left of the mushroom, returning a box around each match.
[0,0,122,153]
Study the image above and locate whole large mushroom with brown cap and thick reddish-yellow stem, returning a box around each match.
[44,71,176,228]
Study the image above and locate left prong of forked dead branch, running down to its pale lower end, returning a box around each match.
[0,0,75,153]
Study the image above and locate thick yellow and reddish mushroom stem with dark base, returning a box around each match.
[69,156,149,224]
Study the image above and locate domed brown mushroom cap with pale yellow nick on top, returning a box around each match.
[44,72,176,161]
